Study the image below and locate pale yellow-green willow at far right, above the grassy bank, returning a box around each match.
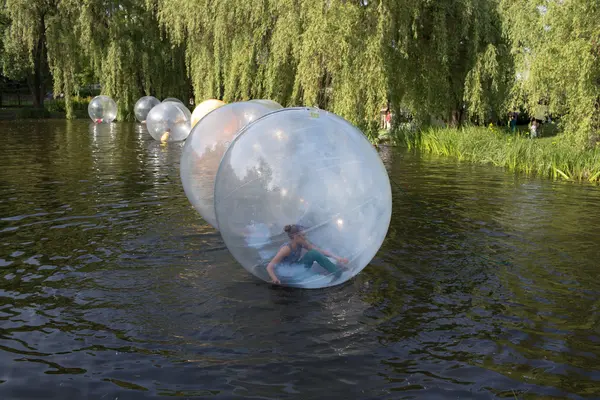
[501,0,600,148]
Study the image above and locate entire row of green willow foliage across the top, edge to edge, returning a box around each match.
[0,0,600,145]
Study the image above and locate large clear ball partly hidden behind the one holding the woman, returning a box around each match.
[180,102,281,229]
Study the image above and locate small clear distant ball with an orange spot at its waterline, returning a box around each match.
[146,102,192,142]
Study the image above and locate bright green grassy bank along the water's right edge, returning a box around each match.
[390,127,600,182]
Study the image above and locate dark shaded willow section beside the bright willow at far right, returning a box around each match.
[385,0,511,126]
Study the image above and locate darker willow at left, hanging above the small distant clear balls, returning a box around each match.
[59,0,190,119]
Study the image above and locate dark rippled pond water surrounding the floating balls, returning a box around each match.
[0,121,600,399]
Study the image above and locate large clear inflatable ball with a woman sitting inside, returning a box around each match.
[214,108,392,288]
